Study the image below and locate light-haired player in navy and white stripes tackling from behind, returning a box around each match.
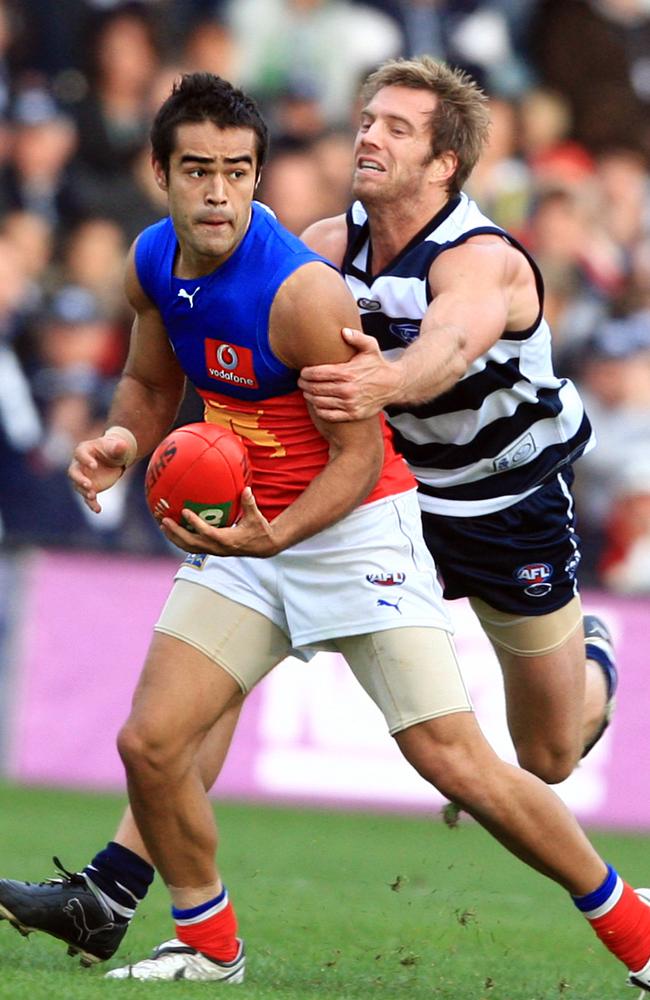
[300,56,617,783]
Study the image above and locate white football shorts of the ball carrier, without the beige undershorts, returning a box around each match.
[176,490,452,647]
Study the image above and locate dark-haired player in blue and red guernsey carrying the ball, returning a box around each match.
[0,74,650,996]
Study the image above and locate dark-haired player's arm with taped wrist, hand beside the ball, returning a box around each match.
[68,238,185,513]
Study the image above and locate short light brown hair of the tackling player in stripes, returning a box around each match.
[361,56,490,194]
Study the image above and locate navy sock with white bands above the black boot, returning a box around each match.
[82,840,154,921]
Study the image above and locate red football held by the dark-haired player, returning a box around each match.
[145,423,251,530]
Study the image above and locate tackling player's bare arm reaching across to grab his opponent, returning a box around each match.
[300,236,536,421]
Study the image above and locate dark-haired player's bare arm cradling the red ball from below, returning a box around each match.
[163,262,384,557]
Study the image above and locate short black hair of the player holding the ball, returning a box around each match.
[150,73,269,174]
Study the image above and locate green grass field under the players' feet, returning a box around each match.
[0,785,650,1000]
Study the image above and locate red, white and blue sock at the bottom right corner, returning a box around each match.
[573,865,650,972]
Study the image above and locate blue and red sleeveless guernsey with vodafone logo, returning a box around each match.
[135,203,414,519]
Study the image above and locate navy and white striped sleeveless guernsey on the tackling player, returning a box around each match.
[343,194,594,517]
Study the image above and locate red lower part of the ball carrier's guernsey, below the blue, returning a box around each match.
[201,391,415,520]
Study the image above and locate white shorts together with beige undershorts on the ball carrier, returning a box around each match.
[156,491,471,733]
